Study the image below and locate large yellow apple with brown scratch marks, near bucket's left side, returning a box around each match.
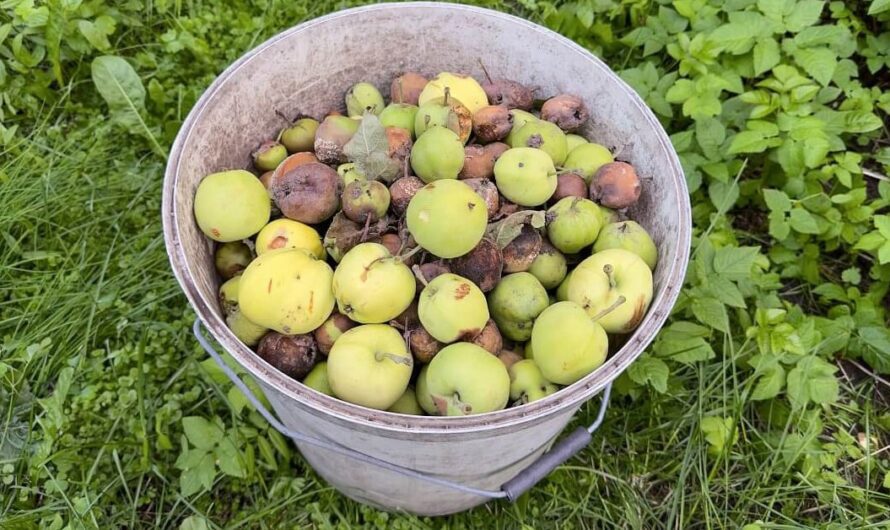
[238,248,334,335]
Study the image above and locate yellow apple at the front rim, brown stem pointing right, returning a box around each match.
[328,324,414,410]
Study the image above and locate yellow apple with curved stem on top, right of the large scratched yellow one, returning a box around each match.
[332,243,416,324]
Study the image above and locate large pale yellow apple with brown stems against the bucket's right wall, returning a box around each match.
[567,248,653,333]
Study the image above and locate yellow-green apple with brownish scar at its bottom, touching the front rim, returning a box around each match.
[426,342,510,416]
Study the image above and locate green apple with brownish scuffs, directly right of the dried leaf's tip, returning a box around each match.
[547,197,602,254]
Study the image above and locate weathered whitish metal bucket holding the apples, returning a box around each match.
[162,3,691,515]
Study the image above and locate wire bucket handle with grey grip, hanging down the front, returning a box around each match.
[192,318,612,501]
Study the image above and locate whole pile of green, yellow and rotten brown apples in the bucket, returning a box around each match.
[194,72,657,416]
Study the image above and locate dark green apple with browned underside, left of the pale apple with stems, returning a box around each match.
[488,272,549,341]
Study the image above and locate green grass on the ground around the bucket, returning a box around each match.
[0,0,890,529]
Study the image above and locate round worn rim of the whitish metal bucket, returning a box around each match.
[161,2,692,434]
